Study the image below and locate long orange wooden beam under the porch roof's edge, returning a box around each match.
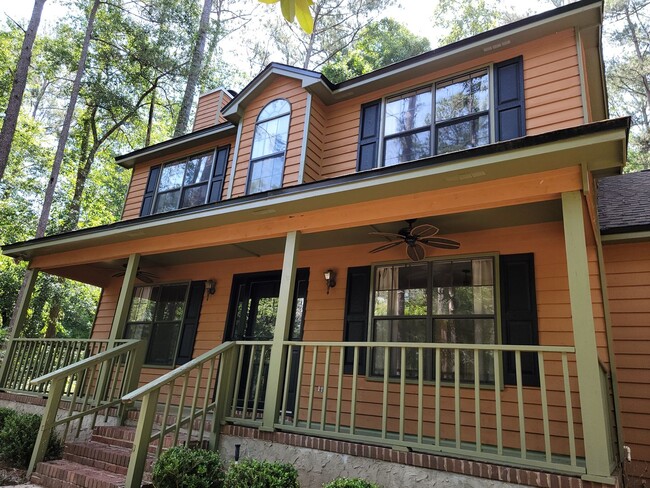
[32,163,582,269]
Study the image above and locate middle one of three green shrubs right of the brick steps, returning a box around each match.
[225,459,300,488]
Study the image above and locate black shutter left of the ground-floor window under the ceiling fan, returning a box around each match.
[343,266,370,374]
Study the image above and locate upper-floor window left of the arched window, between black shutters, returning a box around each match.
[153,153,213,213]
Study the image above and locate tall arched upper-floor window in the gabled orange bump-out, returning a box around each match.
[248,99,291,193]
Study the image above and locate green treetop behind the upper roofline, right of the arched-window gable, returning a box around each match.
[322,18,431,83]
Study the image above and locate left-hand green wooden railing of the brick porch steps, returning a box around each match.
[27,340,146,477]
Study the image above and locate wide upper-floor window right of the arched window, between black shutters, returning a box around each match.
[383,69,490,166]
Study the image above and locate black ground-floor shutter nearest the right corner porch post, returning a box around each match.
[499,253,539,386]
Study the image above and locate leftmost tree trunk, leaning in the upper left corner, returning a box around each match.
[0,0,46,181]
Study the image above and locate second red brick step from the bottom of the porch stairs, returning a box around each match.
[63,441,153,474]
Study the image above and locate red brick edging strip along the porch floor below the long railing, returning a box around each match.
[221,424,621,488]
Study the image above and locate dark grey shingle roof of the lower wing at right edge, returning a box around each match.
[598,170,650,234]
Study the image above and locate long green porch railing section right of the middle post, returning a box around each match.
[275,342,585,474]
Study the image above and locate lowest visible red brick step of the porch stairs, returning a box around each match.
[31,459,151,488]
